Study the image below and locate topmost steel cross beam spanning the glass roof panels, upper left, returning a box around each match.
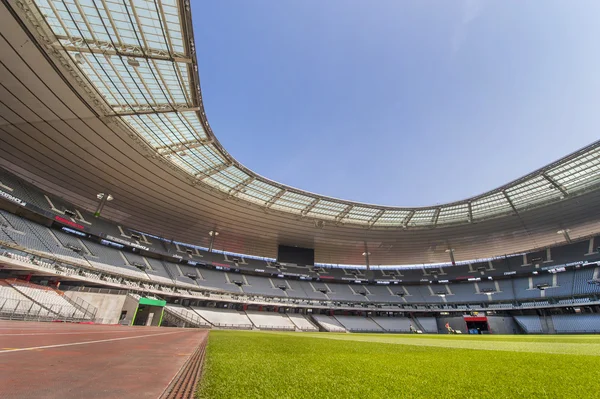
[53,35,192,64]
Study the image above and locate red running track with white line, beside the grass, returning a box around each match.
[0,321,208,399]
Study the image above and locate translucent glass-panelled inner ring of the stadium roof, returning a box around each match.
[4,0,600,261]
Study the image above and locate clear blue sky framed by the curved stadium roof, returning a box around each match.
[192,0,600,206]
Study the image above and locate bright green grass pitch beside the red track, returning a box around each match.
[198,331,600,399]
